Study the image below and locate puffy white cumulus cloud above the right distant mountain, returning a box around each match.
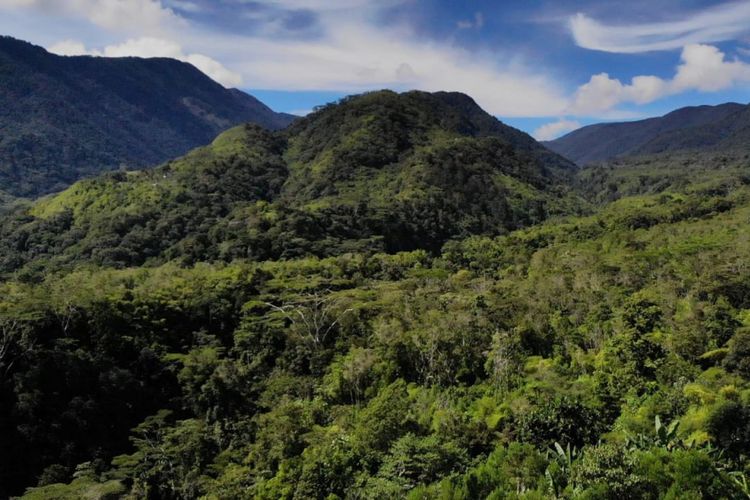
[568,44,750,115]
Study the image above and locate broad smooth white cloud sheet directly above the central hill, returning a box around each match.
[217,23,567,116]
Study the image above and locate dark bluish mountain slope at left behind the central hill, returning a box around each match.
[0,37,294,196]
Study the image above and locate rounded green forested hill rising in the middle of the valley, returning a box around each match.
[0,91,581,278]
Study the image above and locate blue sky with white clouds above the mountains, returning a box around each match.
[0,0,750,140]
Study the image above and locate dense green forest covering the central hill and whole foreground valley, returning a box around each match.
[0,93,750,499]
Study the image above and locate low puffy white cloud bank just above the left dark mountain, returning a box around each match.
[49,37,242,87]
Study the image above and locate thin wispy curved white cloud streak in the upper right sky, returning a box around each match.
[569,0,750,53]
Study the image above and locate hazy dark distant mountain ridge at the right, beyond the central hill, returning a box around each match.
[544,103,750,165]
